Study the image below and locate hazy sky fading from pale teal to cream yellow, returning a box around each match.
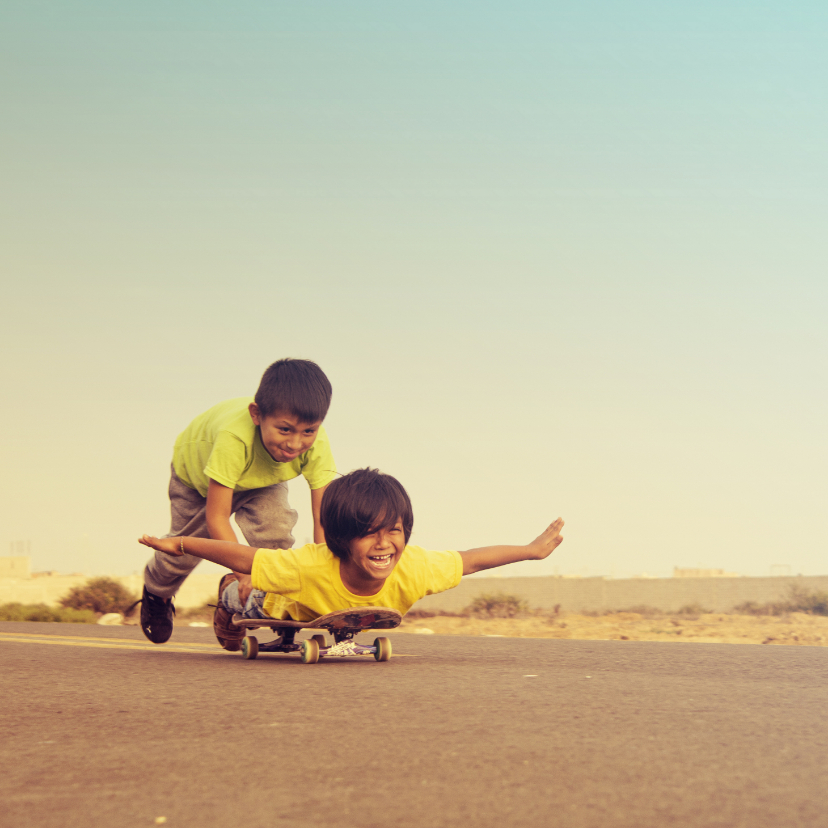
[0,0,828,577]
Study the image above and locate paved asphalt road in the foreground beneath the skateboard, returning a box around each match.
[0,623,828,828]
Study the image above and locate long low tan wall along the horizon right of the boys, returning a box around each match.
[416,575,828,612]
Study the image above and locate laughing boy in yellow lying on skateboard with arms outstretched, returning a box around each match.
[139,469,564,650]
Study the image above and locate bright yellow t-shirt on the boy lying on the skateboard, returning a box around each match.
[251,543,463,621]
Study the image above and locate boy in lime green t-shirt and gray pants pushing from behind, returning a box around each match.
[141,359,336,650]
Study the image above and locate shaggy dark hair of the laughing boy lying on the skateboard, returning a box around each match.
[320,469,414,560]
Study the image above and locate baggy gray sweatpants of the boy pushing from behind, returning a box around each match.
[144,469,297,598]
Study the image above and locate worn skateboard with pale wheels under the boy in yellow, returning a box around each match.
[233,607,402,664]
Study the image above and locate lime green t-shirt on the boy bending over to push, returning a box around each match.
[173,397,336,497]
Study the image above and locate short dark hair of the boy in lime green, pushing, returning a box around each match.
[255,359,332,423]
